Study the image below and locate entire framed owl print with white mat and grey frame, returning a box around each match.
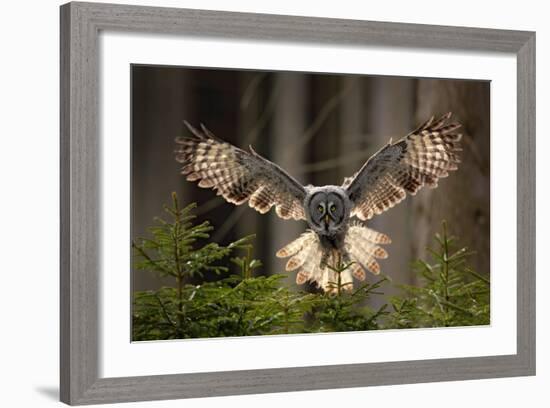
[61,3,535,404]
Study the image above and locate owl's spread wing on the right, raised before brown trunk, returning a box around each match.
[343,112,462,220]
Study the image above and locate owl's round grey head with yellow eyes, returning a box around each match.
[304,186,351,235]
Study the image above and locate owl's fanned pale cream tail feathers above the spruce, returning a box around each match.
[276,223,391,292]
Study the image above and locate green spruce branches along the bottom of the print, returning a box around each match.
[132,194,490,341]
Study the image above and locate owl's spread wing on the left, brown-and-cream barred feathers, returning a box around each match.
[175,122,306,220]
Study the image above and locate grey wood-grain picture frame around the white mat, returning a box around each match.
[60,3,535,404]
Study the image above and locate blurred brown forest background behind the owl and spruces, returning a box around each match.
[131,65,490,306]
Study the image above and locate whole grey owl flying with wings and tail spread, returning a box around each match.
[175,112,462,292]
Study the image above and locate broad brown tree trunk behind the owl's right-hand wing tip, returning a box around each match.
[412,80,490,274]
